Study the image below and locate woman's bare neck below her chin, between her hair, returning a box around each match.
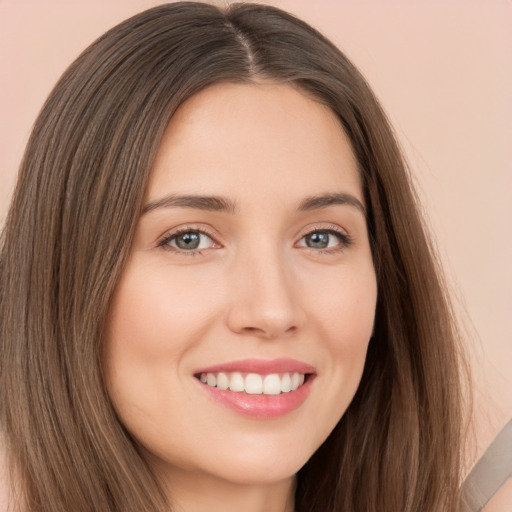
[157,471,295,512]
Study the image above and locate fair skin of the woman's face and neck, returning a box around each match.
[106,83,377,512]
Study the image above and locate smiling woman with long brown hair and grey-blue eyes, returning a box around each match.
[0,3,470,512]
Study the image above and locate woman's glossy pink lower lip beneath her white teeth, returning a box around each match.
[198,375,314,419]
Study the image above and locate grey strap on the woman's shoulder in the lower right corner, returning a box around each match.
[462,420,512,512]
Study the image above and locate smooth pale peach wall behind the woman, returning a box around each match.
[0,0,512,464]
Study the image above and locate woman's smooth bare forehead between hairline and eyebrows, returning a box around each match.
[148,83,363,202]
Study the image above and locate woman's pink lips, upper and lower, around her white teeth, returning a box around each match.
[195,359,316,419]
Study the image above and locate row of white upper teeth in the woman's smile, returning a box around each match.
[199,372,305,395]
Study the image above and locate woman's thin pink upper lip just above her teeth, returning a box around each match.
[194,358,316,375]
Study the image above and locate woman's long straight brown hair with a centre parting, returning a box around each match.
[0,2,468,512]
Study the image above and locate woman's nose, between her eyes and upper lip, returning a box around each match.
[227,245,304,339]
